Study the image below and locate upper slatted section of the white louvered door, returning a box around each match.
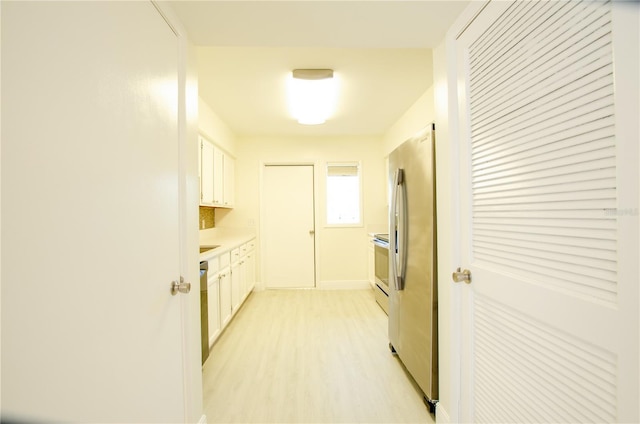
[469,2,617,300]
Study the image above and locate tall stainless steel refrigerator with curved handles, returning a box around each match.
[389,124,438,411]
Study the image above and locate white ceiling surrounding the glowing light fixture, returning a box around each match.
[171,0,469,136]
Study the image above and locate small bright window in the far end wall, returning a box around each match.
[327,162,362,226]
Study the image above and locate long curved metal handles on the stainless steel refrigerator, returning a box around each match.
[389,168,407,290]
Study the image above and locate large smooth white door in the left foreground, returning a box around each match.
[2,2,188,422]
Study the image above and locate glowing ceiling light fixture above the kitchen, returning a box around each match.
[289,69,337,125]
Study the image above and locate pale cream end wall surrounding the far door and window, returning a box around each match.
[216,137,386,288]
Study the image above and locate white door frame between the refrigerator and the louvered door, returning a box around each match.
[434,0,489,423]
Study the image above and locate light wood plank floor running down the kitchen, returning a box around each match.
[203,290,434,423]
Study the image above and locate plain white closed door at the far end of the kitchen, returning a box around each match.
[262,165,315,288]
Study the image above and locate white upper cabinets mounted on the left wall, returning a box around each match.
[200,137,235,208]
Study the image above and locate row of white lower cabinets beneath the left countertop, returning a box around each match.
[208,239,256,346]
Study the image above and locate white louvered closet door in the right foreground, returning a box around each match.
[456,1,640,422]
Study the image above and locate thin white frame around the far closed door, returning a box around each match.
[256,161,321,290]
